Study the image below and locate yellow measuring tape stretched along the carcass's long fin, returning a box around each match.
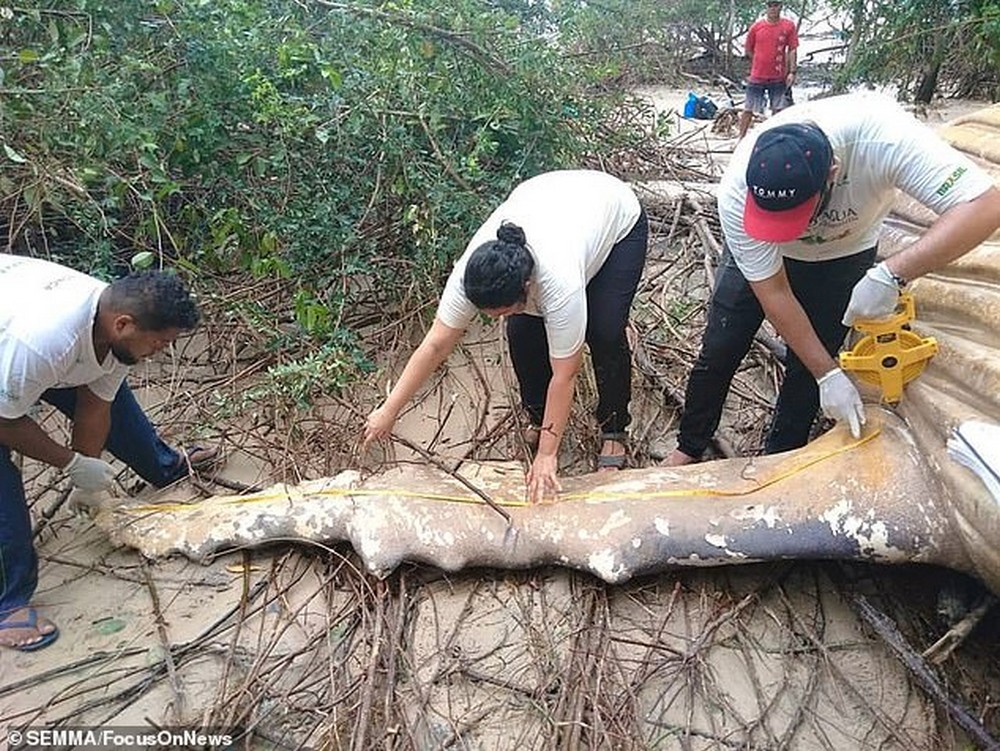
[123,428,882,514]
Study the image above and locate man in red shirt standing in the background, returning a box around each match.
[739,0,799,138]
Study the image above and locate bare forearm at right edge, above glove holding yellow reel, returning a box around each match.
[885,187,1000,281]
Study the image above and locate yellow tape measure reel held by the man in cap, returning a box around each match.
[840,292,938,404]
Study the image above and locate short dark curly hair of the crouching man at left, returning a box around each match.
[100,271,201,331]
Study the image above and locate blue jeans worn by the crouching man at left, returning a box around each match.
[0,383,187,619]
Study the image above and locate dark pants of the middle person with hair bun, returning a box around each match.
[507,211,649,433]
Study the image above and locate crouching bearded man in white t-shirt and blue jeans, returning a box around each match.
[0,253,215,651]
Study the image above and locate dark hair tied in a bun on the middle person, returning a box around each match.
[462,222,535,310]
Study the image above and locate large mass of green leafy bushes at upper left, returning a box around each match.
[0,0,648,406]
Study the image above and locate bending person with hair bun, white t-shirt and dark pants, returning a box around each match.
[364,170,648,502]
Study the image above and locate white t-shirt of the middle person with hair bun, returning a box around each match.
[437,170,640,358]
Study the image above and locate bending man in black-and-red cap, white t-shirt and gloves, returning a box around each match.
[668,94,1000,465]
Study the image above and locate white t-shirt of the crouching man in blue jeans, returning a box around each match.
[0,253,128,420]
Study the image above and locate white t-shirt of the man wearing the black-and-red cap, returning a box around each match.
[719,94,993,282]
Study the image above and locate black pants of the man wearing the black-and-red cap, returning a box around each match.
[677,248,875,458]
